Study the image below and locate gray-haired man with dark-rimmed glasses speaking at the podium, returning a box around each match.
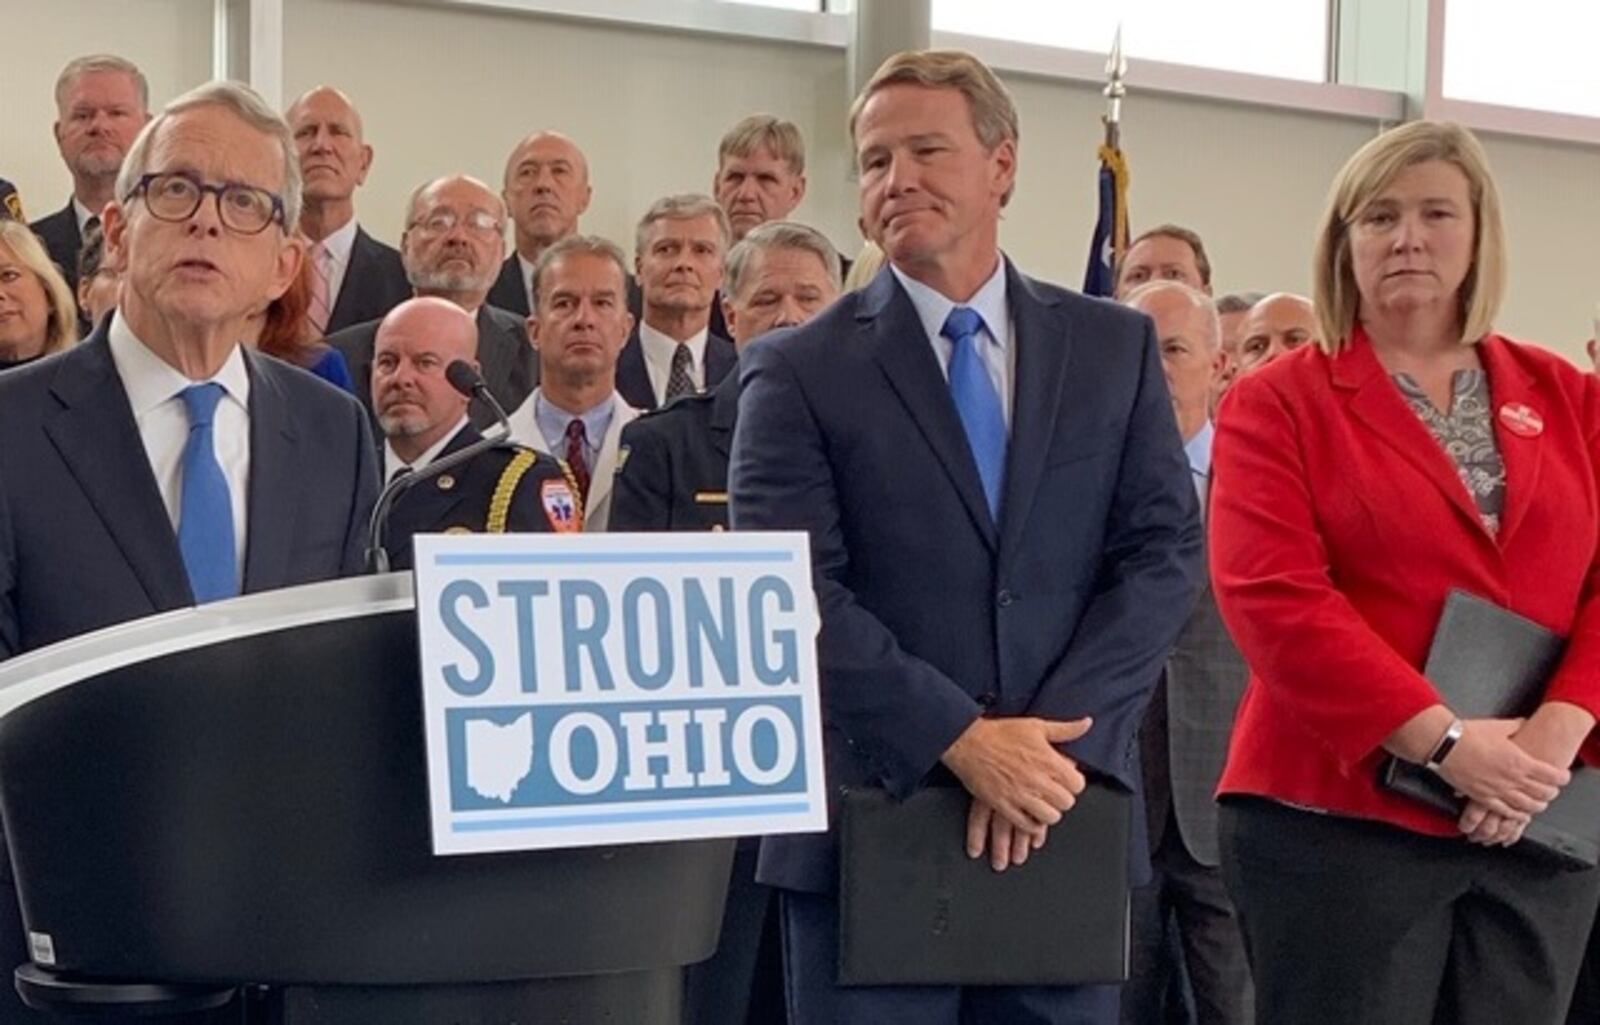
[0,82,378,1022]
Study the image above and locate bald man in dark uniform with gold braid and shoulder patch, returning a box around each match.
[371,297,584,569]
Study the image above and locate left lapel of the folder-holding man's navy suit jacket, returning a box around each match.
[856,267,998,548]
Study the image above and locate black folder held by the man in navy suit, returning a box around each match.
[838,782,1133,985]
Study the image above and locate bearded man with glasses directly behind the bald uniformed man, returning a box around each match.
[326,174,539,430]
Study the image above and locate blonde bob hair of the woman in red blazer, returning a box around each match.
[1312,122,1506,355]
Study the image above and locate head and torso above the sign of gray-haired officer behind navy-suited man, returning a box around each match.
[611,221,838,531]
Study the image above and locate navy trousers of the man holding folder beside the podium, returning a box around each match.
[781,891,1120,1025]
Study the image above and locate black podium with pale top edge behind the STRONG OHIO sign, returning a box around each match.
[0,574,734,1025]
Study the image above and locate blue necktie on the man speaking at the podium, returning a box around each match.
[178,382,238,601]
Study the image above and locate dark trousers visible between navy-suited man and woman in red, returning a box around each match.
[1122,804,1254,1025]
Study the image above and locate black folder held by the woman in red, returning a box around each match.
[1379,590,1600,868]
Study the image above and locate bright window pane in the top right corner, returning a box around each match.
[1445,0,1600,117]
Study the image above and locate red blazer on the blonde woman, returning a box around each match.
[1208,331,1600,835]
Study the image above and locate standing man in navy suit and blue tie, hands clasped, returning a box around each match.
[731,51,1202,1025]
